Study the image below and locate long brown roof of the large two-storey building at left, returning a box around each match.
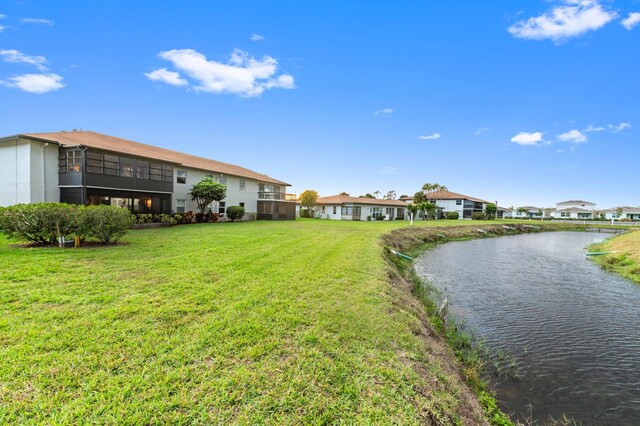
[18,131,290,186]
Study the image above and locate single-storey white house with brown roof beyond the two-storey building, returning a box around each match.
[314,195,407,221]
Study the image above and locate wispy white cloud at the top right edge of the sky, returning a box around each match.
[509,0,617,41]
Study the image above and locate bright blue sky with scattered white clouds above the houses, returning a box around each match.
[0,0,640,208]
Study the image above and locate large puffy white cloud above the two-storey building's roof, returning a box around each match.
[149,49,295,97]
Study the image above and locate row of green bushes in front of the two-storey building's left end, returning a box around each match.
[0,203,134,245]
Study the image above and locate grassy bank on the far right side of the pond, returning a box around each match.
[590,230,640,284]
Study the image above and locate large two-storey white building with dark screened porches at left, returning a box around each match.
[0,131,295,220]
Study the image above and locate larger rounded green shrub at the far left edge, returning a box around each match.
[0,203,78,245]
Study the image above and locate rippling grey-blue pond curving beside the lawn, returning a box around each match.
[415,232,640,424]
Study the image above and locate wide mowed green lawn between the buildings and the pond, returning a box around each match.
[0,220,496,424]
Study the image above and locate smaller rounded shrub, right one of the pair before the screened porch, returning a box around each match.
[79,206,134,244]
